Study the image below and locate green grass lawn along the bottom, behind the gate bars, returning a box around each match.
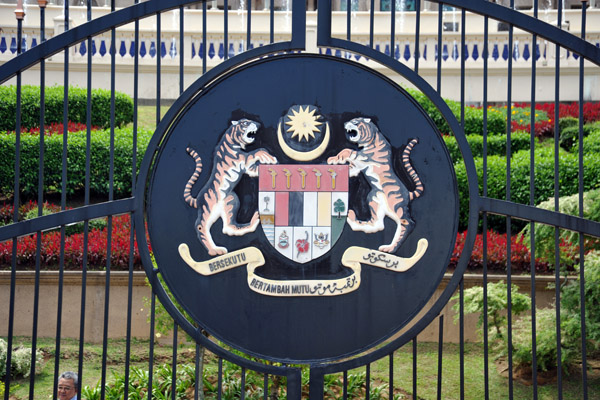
[5,338,600,400]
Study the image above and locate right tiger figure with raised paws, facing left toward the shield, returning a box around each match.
[327,117,423,253]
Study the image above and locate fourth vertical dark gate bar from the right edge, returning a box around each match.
[506,0,515,399]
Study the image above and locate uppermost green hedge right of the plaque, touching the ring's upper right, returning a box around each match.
[407,89,506,135]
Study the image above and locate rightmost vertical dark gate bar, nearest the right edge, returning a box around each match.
[578,0,588,400]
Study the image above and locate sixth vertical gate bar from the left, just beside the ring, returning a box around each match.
[123,0,140,399]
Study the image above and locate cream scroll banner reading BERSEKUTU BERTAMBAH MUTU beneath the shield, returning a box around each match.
[179,239,427,297]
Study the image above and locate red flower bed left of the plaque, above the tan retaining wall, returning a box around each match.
[0,215,149,270]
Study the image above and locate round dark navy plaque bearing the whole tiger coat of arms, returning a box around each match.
[146,55,458,362]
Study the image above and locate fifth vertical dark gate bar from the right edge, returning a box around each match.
[481,9,490,400]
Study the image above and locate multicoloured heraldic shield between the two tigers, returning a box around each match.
[258,164,349,263]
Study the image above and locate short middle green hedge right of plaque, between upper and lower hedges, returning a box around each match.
[444,132,531,162]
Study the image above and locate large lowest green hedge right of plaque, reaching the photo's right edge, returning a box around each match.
[455,147,600,232]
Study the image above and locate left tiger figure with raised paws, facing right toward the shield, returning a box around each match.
[183,118,277,256]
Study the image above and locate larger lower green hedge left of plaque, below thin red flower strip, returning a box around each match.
[0,128,153,197]
